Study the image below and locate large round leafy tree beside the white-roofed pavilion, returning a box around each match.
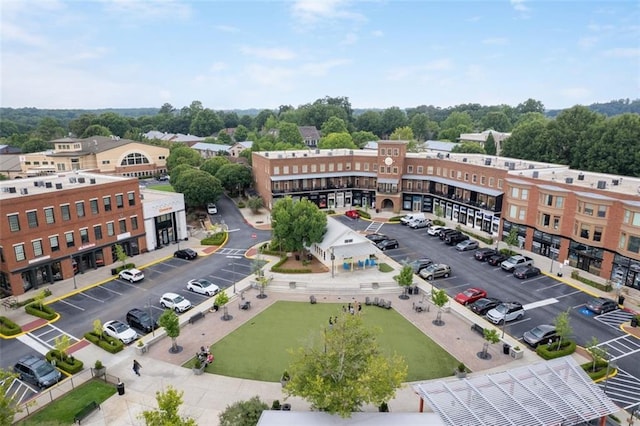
[271,197,327,251]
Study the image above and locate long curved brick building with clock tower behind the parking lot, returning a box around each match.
[253,141,640,288]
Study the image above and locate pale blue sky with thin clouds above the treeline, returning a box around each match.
[0,0,640,110]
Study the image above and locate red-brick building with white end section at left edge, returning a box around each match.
[0,172,187,295]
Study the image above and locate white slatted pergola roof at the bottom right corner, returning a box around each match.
[414,356,619,426]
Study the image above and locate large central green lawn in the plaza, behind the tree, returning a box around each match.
[192,301,458,382]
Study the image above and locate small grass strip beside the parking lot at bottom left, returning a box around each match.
[17,380,116,426]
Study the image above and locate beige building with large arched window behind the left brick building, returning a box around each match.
[20,136,169,177]
